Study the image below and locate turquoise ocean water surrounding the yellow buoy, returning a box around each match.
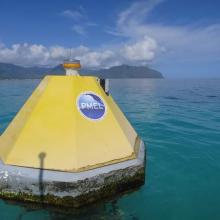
[0,79,220,220]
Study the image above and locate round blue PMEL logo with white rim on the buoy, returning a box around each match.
[77,92,106,120]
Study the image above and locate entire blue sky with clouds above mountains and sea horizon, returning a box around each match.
[0,0,220,78]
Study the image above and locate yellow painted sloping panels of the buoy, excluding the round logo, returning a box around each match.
[0,76,137,172]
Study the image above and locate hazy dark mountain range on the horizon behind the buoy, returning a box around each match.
[0,63,163,79]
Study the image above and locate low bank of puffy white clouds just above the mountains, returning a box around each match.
[0,37,157,68]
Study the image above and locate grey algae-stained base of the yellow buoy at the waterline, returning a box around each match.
[0,141,146,207]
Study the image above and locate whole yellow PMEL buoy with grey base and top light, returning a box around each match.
[0,60,145,207]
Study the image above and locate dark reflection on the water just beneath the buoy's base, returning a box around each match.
[0,197,127,220]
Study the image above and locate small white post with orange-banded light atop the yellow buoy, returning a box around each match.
[63,59,81,76]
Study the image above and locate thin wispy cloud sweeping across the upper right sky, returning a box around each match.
[107,0,220,62]
